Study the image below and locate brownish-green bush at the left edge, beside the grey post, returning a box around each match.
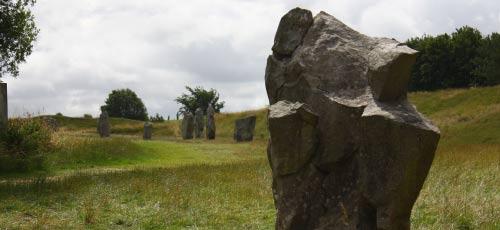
[0,118,52,172]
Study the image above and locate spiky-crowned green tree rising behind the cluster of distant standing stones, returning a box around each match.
[174,86,225,114]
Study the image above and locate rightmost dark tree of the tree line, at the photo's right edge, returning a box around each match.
[473,33,500,86]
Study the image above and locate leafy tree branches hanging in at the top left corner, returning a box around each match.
[0,0,39,78]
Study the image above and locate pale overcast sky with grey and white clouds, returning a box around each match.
[2,0,500,118]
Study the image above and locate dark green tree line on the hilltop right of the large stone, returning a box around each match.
[406,26,500,91]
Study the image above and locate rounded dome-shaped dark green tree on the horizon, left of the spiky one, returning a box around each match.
[101,89,148,121]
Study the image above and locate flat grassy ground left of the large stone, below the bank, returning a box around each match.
[0,141,274,229]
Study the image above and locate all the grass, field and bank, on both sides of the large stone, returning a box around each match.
[0,86,500,229]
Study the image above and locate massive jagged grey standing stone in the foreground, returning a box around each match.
[265,8,440,229]
